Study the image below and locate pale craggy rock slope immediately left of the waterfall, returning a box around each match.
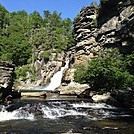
[16,49,66,89]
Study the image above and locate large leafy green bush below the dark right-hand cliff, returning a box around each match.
[75,49,134,91]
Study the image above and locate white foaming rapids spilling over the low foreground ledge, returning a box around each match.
[0,100,131,122]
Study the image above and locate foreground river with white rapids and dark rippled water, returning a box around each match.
[0,100,134,134]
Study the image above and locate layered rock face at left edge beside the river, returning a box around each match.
[0,61,15,98]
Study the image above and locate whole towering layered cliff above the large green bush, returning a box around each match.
[74,0,134,64]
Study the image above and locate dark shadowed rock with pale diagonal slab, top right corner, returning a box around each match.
[96,0,134,53]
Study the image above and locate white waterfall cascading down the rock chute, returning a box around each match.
[41,60,69,91]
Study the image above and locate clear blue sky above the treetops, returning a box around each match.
[0,0,99,19]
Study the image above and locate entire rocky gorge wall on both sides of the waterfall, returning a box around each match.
[17,0,134,93]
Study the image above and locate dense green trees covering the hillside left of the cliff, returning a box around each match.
[0,5,74,80]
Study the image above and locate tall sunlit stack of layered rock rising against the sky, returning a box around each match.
[74,6,100,64]
